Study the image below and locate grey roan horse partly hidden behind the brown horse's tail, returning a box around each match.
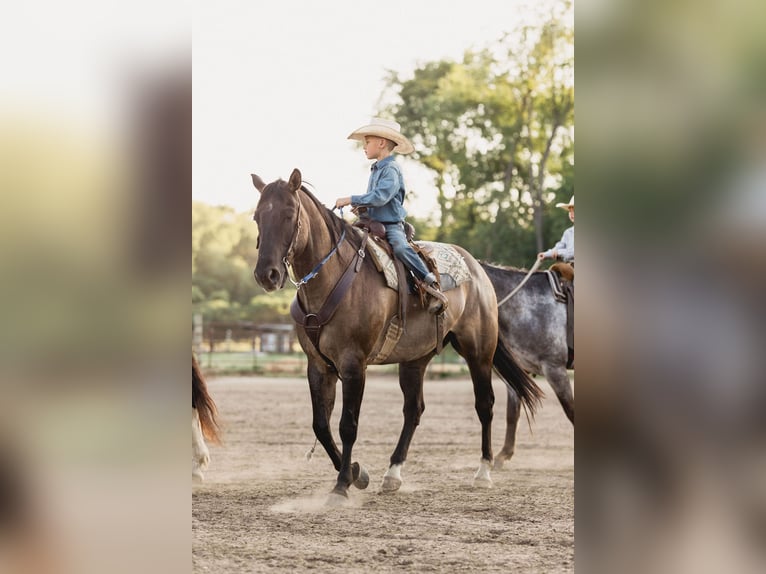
[481,262,574,469]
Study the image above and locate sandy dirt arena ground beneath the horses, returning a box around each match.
[192,375,574,574]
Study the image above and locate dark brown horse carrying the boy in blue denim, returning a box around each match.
[252,169,542,504]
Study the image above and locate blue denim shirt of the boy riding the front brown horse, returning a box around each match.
[351,155,407,223]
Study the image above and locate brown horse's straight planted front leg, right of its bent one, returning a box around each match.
[333,362,369,499]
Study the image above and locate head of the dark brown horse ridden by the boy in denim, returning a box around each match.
[252,169,302,291]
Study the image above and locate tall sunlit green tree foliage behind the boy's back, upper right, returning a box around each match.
[382,6,574,265]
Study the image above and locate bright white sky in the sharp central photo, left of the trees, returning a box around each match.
[192,0,552,217]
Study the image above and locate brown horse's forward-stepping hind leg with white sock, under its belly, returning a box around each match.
[380,354,433,492]
